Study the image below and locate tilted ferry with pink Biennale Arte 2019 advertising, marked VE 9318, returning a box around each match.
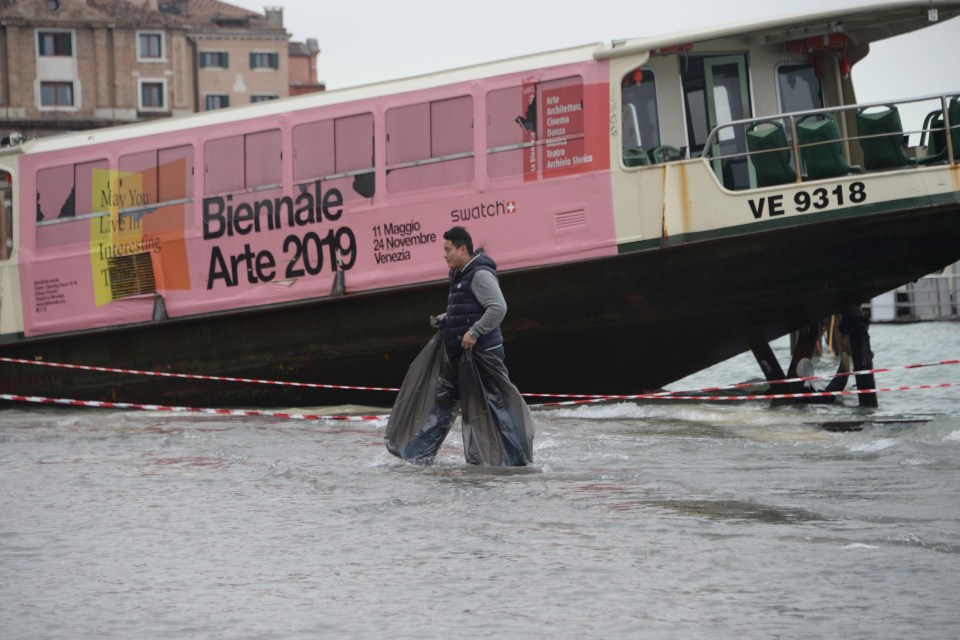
[0,0,960,406]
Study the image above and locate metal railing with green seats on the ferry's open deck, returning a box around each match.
[703,94,960,190]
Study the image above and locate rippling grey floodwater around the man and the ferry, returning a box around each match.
[0,323,960,640]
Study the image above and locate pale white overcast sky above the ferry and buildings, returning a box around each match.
[232,0,960,102]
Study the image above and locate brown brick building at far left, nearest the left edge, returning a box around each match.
[0,0,194,135]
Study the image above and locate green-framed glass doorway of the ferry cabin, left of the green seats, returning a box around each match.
[681,53,753,189]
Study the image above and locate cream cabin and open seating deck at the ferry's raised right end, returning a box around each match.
[612,3,960,185]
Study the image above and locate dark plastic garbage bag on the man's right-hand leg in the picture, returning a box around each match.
[459,351,534,467]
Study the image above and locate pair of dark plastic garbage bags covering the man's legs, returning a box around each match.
[384,332,534,467]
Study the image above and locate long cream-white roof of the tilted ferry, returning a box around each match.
[4,0,960,153]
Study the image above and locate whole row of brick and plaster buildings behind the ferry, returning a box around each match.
[0,0,323,137]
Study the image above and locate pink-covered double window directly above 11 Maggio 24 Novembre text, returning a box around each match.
[386,96,474,192]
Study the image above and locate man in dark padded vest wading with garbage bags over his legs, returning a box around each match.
[386,227,533,466]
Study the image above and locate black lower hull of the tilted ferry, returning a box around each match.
[0,203,960,407]
